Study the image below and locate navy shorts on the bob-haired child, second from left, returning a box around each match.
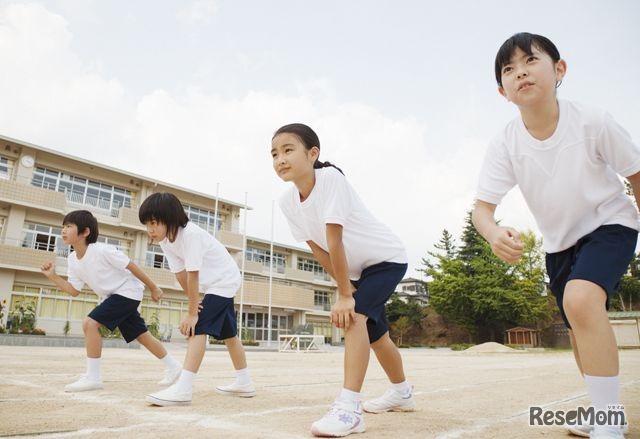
[195,294,238,340]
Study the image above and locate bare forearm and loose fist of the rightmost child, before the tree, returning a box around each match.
[471,200,524,264]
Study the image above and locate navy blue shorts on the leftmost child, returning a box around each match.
[89,294,148,343]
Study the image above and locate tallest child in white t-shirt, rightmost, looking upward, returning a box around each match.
[473,33,640,438]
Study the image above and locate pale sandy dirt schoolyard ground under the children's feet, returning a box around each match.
[0,343,640,439]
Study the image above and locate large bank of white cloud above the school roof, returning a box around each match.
[0,2,544,275]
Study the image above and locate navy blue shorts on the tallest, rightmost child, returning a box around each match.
[546,224,638,328]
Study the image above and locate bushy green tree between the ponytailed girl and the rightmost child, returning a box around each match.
[425,213,551,341]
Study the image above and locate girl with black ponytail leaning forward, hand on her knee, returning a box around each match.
[271,124,415,436]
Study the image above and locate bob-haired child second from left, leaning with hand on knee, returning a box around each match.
[138,192,256,406]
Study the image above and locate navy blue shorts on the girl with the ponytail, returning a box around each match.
[351,262,407,343]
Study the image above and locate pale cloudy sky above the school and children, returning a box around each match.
[0,0,640,277]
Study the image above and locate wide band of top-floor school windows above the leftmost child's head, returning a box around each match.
[31,167,132,216]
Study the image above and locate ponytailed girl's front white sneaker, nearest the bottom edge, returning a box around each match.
[311,399,366,437]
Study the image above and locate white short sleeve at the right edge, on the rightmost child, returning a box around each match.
[597,113,640,177]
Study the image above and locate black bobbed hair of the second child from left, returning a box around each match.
[138,192,189,242]
